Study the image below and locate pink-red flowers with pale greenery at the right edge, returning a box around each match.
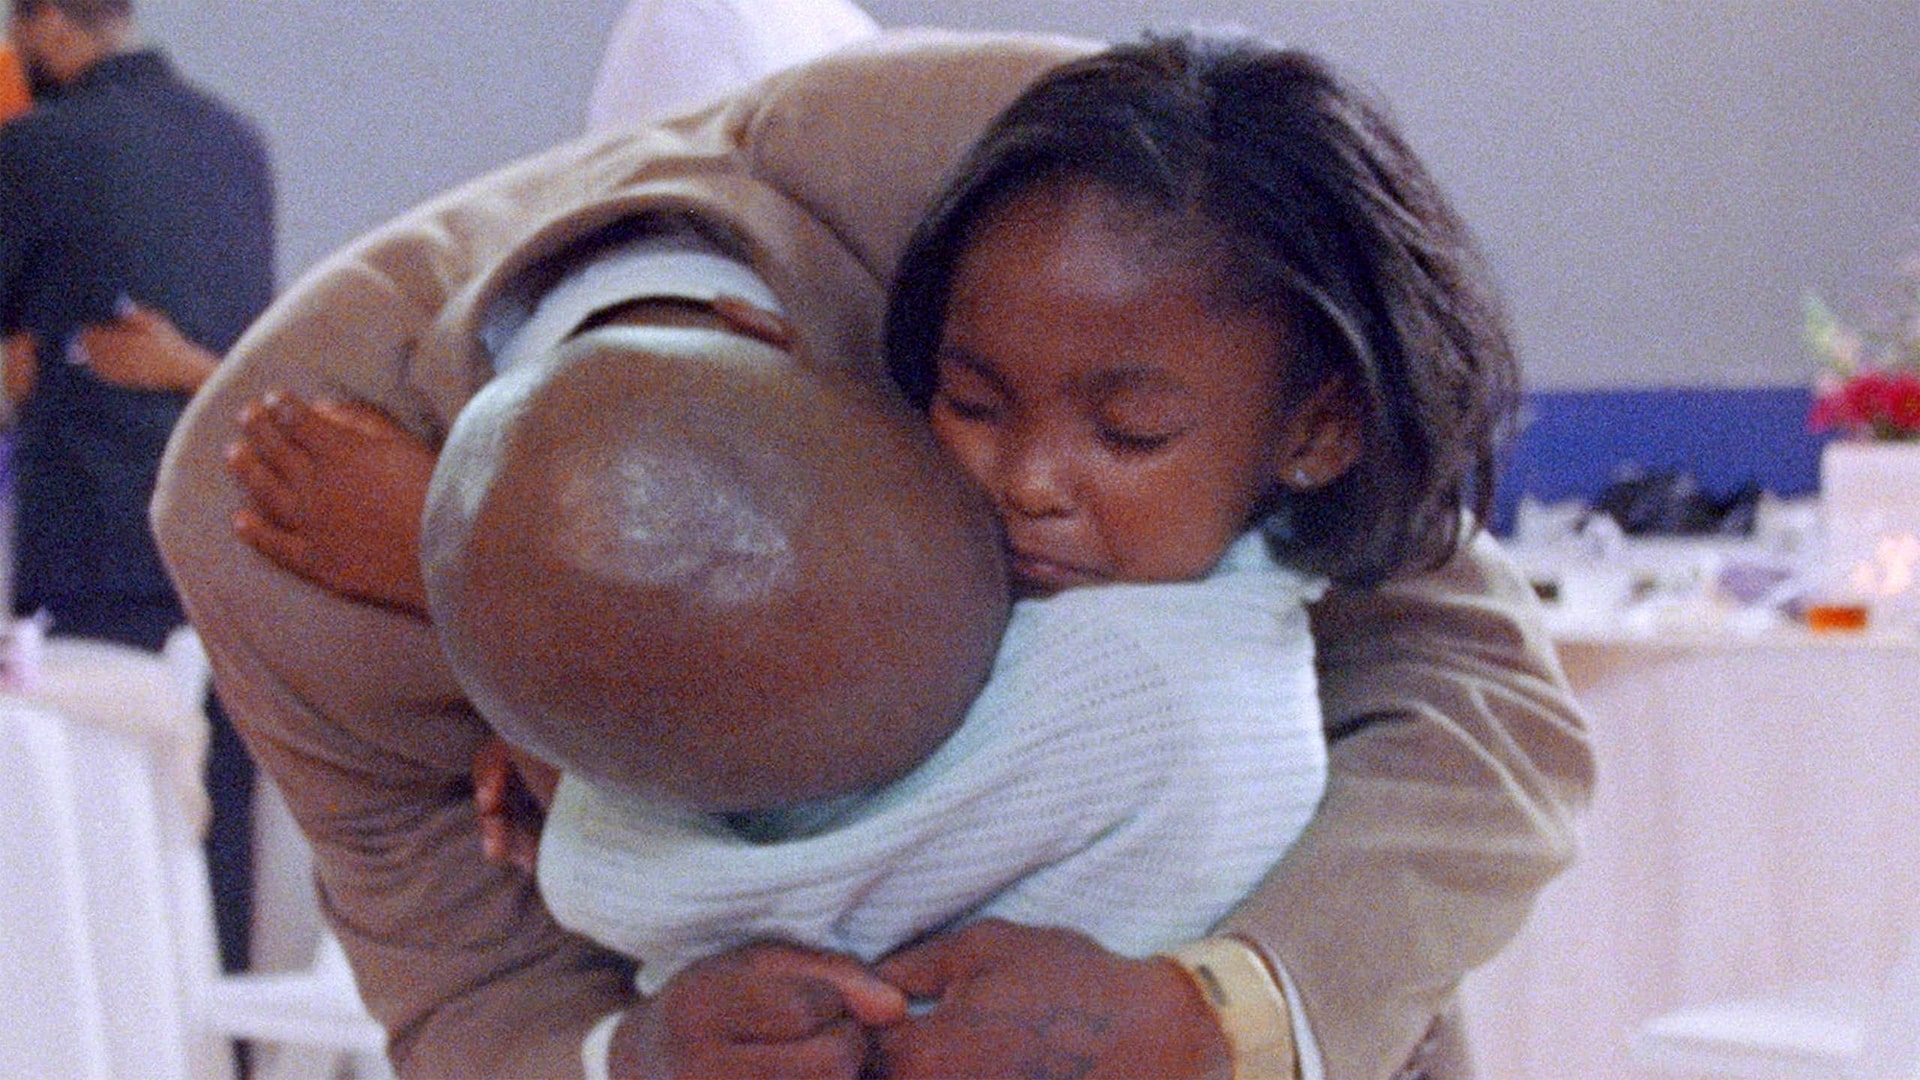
[1805,254,1920,440]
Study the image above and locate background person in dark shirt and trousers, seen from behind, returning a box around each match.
[0,0,273,969]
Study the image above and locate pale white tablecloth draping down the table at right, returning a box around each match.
[1467,630,1920,1080]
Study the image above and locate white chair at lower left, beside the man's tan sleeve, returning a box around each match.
[0,640,392,1080]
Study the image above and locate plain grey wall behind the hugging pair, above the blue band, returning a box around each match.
[142,0,1920,386]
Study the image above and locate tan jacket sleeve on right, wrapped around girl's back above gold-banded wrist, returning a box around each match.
[1223,534,1594,1080]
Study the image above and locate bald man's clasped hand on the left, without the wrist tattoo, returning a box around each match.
[609,942,906,1080]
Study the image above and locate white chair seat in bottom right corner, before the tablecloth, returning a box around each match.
[1634,934,1920,1080]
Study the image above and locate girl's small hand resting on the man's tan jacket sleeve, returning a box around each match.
[227,392,434,619]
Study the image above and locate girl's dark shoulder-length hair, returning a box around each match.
[887,35,1519,584]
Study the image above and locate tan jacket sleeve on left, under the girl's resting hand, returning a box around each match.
[154,145,628,1078]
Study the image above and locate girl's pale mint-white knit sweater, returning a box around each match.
[540,536,1327,992]
